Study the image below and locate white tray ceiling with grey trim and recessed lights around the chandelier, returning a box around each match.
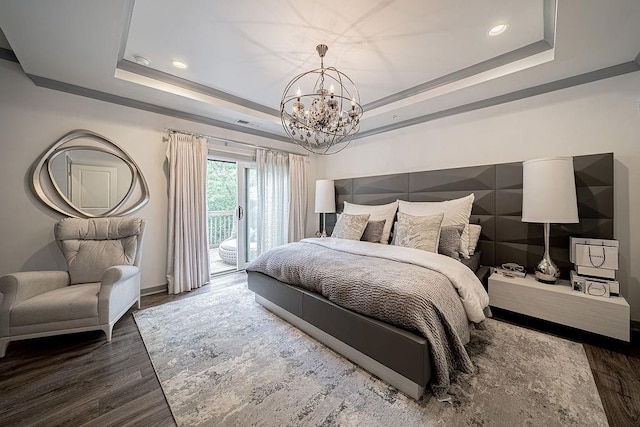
[0,0,640,145]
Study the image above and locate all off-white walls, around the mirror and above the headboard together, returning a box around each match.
[0,53,640,320]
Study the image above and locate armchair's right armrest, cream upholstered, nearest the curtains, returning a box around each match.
[98,265,140,323]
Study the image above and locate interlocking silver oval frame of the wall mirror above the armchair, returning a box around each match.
[31,129,149,218]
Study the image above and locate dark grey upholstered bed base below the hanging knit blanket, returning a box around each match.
[247,271,432,400]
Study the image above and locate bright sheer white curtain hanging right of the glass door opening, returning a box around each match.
[256,149,290,255]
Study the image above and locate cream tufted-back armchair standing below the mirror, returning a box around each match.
[0,217,145,357]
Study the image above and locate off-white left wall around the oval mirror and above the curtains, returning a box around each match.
[0,60,314,289]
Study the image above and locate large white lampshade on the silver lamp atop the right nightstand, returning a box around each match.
[522,157,580,224]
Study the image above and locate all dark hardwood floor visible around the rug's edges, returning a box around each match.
[0,273,640,426]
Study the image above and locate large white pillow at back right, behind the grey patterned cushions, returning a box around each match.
[398,193,475,259]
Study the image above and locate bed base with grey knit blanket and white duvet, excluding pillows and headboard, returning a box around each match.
[248,234,488,399]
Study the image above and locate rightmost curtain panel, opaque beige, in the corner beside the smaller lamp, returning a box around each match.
[288,154,307,242]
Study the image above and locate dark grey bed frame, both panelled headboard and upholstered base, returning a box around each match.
[247,153,613,400]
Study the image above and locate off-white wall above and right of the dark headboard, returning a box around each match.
[316,72,640,321]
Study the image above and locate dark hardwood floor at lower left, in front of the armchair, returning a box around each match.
[0,304,175,426]
